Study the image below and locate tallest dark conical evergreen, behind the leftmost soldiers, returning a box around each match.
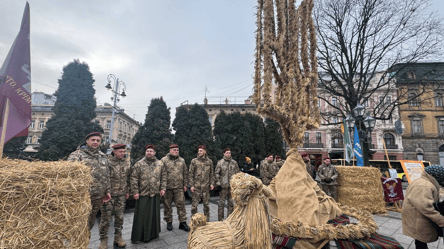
[38,60,103,160]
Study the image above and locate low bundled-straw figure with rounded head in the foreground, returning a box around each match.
[188,173,272,249]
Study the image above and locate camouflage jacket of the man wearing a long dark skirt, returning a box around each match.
[130,157,167,197]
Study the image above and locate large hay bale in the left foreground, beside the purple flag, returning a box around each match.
[0,159,92,248]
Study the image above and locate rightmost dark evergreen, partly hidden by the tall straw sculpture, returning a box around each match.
[265,118,285,160]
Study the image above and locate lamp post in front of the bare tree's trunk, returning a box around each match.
[344,103,376,166]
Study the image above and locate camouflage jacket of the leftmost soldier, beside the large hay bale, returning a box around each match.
[68,145,111,198]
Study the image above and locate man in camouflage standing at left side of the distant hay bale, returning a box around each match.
[318,157,338,201]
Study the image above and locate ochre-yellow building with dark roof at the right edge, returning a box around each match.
[397,62,444,166]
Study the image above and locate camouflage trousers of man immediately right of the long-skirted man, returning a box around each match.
[163,188,187,223]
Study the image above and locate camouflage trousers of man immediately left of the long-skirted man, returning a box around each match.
[99,196,126,239]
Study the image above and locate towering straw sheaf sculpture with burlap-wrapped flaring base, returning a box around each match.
[253,0,377,248]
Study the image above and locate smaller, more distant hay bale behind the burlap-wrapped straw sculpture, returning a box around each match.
[336,166,387,214]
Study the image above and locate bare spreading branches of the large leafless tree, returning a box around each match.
[314,0,443,122]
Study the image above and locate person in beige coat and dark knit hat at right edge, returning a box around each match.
[401,165,444,249]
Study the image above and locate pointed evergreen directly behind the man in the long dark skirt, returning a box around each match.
[131,97,172,164]
